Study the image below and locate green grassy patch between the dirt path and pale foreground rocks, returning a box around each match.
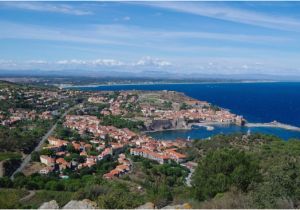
[23,190,74,208]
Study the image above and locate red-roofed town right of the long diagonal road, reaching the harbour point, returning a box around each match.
[30,91,243,179]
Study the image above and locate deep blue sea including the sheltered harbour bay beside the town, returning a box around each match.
[78,82,300,140]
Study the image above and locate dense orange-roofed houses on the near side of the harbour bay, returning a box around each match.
[40,111,186,179]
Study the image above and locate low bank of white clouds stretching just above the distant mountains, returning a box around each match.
[0,56,300,76]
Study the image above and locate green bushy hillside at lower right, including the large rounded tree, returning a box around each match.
[189,134,300,208]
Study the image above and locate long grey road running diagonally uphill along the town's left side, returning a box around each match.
[10,104,80,180]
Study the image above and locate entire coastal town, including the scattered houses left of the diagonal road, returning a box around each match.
[1,85,245,179]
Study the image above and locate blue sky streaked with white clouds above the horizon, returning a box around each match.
[0,1,300,76]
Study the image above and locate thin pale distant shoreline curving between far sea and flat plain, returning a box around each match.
[60,80,281,89]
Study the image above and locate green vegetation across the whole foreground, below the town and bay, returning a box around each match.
[0,130,300,208]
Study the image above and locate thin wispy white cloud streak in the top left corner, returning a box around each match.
[0,2,93,16]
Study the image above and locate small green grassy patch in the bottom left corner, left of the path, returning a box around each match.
[0,189,28,209]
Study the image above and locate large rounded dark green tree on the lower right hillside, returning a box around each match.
[192,149,260,200]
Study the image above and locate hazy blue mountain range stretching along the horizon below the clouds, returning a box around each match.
[0,69,300,81]
